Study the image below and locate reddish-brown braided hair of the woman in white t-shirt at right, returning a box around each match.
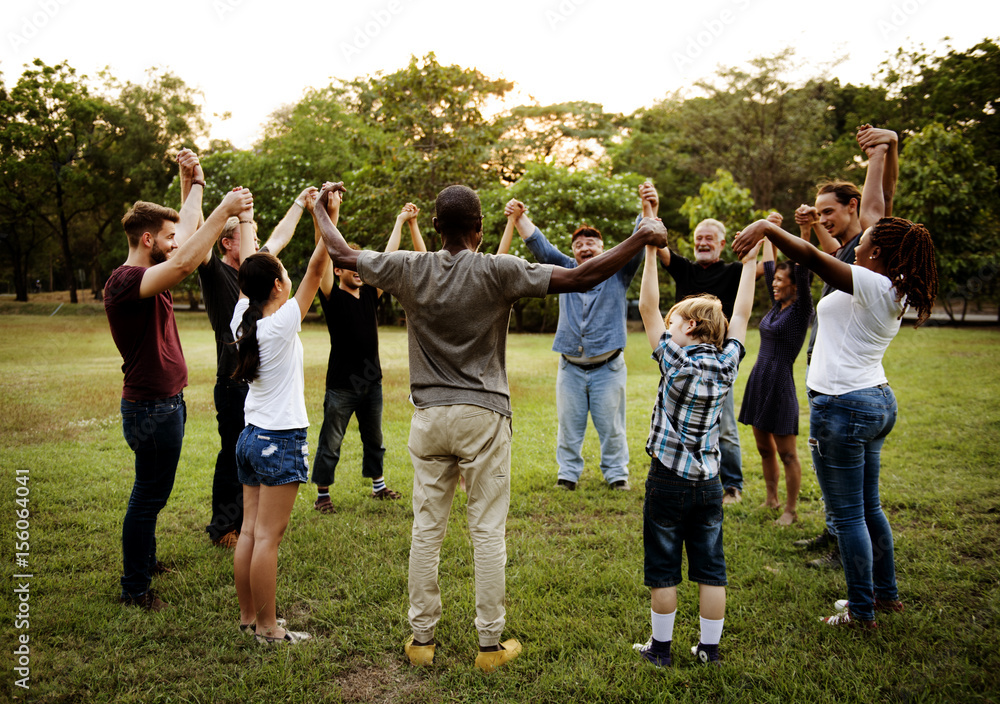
[870,218,938,328]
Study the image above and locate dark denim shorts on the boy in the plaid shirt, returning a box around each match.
[642,458,727,588]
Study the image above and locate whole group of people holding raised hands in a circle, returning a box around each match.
[105,125,937,672]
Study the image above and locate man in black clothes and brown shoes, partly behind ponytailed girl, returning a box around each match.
[181,157,318,549]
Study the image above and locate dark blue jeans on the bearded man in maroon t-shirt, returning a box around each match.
[121,394,187,599]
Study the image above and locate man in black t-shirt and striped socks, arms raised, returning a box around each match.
[312,201,427,513]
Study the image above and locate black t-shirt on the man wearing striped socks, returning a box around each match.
[319,285,382,389]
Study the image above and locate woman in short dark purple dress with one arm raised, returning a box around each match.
[739,242,813,526]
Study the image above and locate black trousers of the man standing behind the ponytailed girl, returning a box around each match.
[205,379,250,540]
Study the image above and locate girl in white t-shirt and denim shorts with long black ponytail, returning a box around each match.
[231,186,339,644]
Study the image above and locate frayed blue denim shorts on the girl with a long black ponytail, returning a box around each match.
[236,425,309,486]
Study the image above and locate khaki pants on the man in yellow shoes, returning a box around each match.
[408,405,511,647]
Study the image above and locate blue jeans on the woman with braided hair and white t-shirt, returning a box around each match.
[809,384,898,620]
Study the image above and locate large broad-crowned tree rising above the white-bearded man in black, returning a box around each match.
[609,50,877,236]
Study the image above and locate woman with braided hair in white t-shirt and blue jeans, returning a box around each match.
[733,218,938,628]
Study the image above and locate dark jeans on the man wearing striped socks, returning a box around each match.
[312,381,385,486]
